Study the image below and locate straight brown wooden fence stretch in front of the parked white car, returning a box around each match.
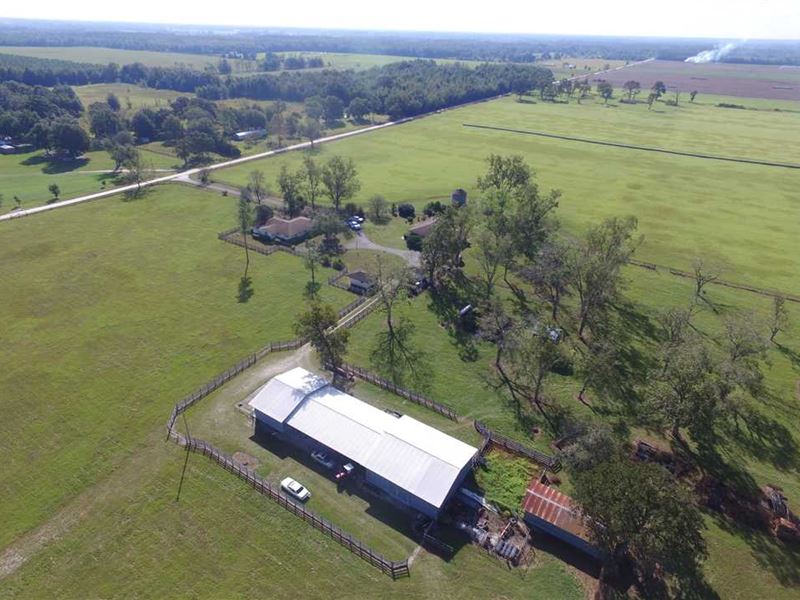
[177,432,410,579]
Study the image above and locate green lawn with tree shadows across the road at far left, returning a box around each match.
[0,147,180,214]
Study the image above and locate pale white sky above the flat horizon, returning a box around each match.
[0,0,800,40]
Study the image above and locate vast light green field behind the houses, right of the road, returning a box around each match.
[214,93,800,293]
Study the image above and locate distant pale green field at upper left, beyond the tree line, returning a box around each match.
[0,46,255,71]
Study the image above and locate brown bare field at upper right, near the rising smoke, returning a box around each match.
[592,60,800,100]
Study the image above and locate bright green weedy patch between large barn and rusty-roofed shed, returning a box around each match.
[475,448,538,513]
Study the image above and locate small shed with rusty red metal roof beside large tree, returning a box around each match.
[523,480,601,558]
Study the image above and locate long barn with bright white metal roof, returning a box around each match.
[250,368,478,519]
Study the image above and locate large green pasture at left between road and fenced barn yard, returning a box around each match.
[0,185,351,547]
